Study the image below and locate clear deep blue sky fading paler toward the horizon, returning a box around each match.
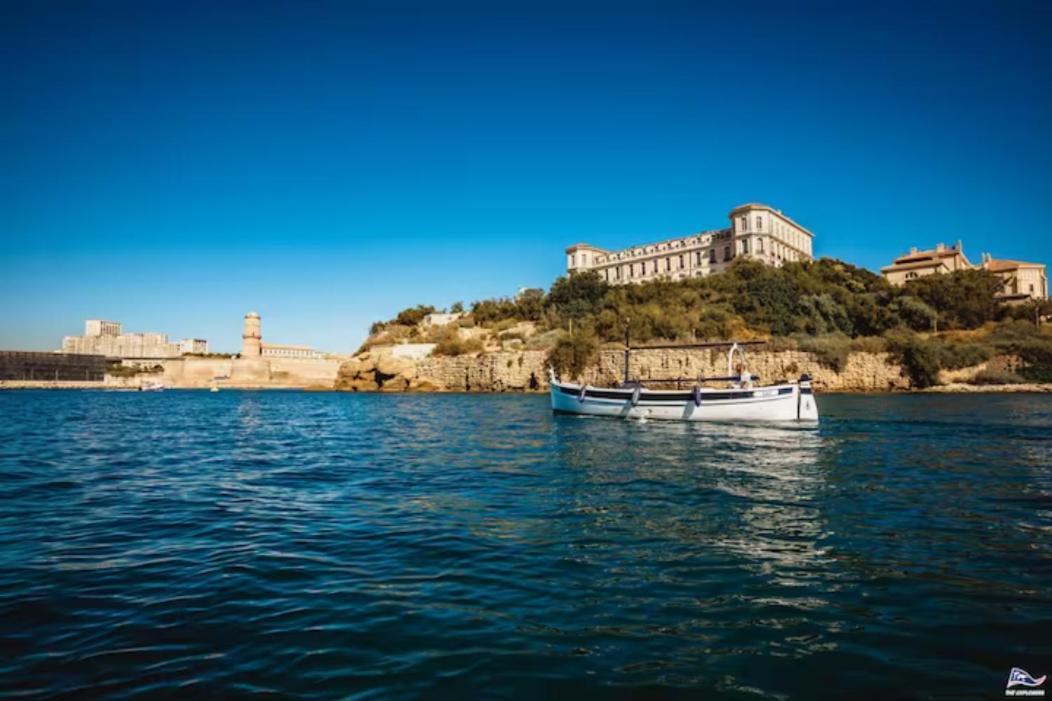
[0,0,1052,352]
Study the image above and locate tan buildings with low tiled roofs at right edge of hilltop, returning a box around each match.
[881,241,1049,303]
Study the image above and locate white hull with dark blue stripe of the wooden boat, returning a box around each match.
[550,380,818,422]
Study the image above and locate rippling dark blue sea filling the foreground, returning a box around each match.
[0,392,1052,699]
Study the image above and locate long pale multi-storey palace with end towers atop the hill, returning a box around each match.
[566,203,814,284]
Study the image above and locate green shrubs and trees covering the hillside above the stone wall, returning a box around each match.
[370,258,1052,386]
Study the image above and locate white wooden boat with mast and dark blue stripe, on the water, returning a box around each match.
[549,342,818,422]
